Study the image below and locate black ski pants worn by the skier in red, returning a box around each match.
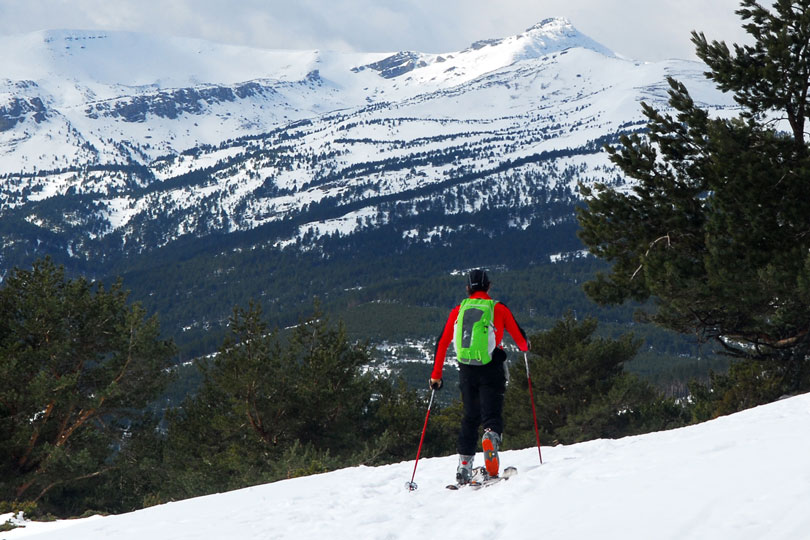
[457,349,506,456]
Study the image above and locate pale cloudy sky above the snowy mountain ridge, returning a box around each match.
[0,0,746,61]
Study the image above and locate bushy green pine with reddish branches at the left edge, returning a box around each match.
[0,259,174,514]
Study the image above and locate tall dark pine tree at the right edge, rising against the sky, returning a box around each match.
[579,0,810,413]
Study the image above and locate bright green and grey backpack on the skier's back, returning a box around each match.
[453,298,497,366]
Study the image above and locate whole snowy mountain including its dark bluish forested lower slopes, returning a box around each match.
[0,18,735,346]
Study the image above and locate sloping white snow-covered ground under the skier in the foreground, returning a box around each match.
[0,394,810,540]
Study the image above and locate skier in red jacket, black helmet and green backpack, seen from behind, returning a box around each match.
[430,269,531,485]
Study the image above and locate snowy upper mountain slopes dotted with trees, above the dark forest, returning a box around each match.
[0,19,731,258]
